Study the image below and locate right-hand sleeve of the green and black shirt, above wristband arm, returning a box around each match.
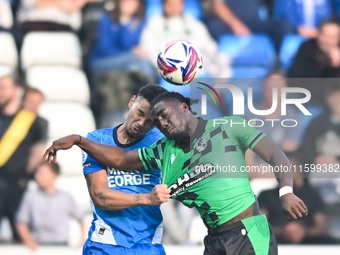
[227,116,265,150]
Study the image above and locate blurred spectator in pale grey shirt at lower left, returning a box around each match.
[16,162,85,249]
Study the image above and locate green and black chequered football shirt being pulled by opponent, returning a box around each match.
[138,117,264,228]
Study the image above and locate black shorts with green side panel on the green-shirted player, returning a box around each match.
[204,215,278,255]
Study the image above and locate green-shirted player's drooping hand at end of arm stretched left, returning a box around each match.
[43,135,79,163]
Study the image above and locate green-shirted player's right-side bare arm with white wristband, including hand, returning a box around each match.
[254,137,308,220]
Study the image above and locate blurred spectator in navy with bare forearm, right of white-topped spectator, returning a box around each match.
[202,0,291,49]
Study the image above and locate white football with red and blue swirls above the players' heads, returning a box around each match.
[157,40,203,85]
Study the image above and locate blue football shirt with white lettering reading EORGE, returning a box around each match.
[83,127,163,248]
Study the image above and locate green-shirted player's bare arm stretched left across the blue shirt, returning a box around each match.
[43,135,143,170]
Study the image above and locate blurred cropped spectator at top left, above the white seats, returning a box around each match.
[18,0,86,34]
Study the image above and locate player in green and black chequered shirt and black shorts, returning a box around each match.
[44,92,308,255]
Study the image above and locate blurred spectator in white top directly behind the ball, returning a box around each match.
[141,0,230,78]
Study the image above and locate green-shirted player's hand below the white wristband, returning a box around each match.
[281,193,308,220]
